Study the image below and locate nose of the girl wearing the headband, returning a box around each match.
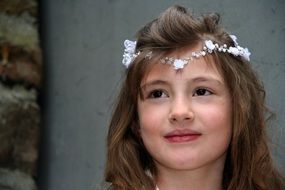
[169,98,194,123]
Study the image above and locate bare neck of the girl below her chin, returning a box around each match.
[157,159,224,190]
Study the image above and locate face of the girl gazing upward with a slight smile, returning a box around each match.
[138,48,232,174]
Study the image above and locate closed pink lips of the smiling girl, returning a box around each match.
[164,129,202,143]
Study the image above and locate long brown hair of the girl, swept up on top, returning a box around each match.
[105,6,285,190]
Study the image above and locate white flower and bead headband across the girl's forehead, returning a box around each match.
[122,35,251,69]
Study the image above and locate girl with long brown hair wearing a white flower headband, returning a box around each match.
[105,6,285,190]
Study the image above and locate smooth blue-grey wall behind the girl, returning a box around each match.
[39,0,285,190]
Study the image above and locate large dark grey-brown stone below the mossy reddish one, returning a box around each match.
[0,85,40,176]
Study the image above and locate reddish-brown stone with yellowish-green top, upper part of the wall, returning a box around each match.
[0,8,42,88]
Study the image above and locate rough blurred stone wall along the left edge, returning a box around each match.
[0,0,42,190]
